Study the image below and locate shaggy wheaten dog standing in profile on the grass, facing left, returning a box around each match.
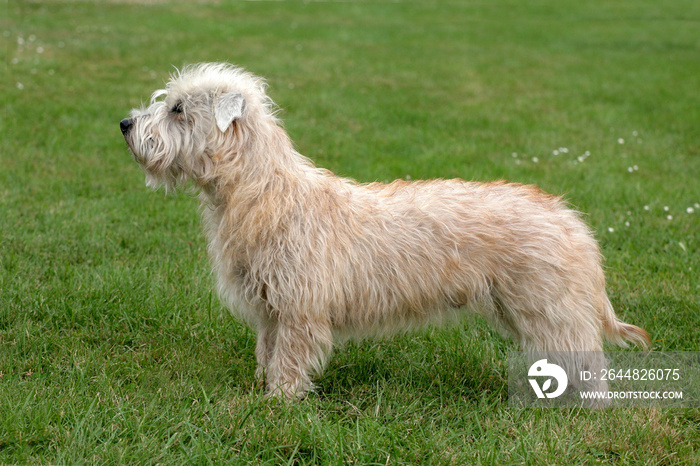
[120,63,649,399]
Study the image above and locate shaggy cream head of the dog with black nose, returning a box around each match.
[120,64,273,189]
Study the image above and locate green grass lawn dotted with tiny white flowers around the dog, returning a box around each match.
[0,0,700,464]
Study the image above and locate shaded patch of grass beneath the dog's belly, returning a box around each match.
[316,329,508,403]
